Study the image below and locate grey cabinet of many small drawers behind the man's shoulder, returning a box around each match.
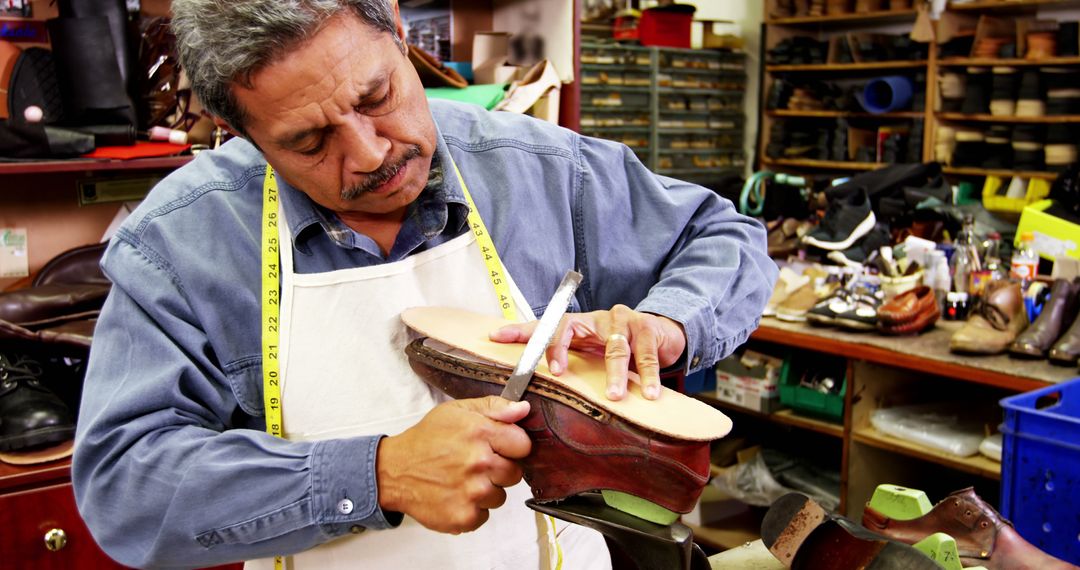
[581,42,746,181]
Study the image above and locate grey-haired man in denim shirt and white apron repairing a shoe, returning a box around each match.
[72,0,775,569]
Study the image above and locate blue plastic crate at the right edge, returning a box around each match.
[1001,378,1080,564]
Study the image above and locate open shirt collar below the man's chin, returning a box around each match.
[278,115,469,253]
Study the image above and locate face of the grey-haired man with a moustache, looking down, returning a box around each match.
[233,14,435,221]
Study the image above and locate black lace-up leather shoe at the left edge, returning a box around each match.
[0,353,75,451]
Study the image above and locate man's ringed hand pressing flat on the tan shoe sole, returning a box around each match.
[490,304,686,399]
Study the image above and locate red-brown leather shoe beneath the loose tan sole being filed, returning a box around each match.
[405,339,710,513]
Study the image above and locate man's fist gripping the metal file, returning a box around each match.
[375,396,532,534]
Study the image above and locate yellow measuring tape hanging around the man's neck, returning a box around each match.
[262,162,563,570]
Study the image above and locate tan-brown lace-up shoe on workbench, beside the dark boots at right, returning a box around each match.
[948,281,1027,354]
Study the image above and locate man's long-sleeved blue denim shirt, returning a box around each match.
[72,101,777,568]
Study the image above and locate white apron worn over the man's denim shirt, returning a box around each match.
[246,174,610,570]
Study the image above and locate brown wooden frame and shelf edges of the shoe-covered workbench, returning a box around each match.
[694,320,1076,527]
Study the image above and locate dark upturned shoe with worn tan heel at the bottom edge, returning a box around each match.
[761,493,941,570]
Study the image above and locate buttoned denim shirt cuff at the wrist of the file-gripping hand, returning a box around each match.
[311,435,404,537]
